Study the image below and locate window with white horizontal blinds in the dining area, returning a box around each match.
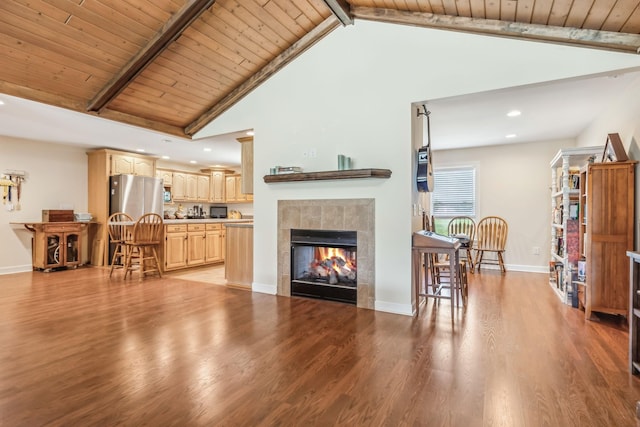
[431,167,476,218]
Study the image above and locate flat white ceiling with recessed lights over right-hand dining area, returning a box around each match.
[424,71,640,150]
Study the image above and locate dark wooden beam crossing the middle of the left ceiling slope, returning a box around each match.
[87,0,215,111]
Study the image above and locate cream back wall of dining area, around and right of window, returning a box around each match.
[433,140,575,273]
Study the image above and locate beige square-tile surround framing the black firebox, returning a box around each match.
[278,199,375,309]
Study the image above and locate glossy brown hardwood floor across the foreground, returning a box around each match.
[0,268,640,427]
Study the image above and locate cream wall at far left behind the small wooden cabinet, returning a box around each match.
[0,136,87,274]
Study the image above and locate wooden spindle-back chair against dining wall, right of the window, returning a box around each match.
[475,216,509,274]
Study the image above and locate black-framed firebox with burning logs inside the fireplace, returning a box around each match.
[291,229,358,304]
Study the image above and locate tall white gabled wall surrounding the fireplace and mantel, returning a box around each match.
[197,21,640,314]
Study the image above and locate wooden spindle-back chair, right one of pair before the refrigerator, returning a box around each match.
[124,213,164,280]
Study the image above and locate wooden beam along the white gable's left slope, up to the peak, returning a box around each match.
[185,15,340,136]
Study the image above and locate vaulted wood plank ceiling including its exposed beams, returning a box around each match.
[0,0,640,137]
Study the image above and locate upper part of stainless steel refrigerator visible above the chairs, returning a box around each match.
[109,175,164,221]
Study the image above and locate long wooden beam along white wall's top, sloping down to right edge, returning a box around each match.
[351,7,640,53]
